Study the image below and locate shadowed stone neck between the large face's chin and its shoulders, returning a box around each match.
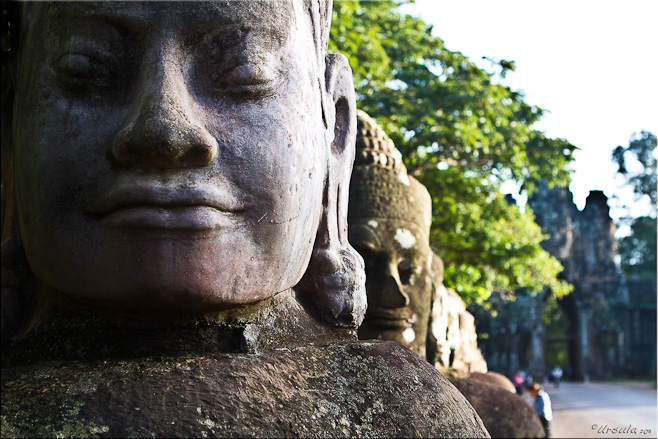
[2,290,356,366]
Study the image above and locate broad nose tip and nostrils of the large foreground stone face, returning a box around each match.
[112,85,218,169]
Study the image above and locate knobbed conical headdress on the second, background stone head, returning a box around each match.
[348,110,432,236]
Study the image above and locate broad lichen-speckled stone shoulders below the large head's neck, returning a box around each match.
[2,341,486,437]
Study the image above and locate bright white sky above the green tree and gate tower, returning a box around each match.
[400,0,658,223]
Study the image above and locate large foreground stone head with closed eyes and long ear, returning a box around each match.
[2,0,364,342]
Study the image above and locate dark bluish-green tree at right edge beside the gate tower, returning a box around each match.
[612,131,657,279]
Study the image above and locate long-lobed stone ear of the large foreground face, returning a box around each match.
[295,54,366,327]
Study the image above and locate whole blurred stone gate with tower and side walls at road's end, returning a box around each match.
[476,186,656,380]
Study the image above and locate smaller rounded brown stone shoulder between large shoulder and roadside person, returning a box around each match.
[450,378,545,438]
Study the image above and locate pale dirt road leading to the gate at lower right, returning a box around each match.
[546,383,658,438]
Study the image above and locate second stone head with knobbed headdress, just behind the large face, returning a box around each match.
[348,111,433,357]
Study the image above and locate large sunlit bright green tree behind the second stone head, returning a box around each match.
[330,1,575,302]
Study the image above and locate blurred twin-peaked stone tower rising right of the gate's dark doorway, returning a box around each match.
[529,187,629,379]
